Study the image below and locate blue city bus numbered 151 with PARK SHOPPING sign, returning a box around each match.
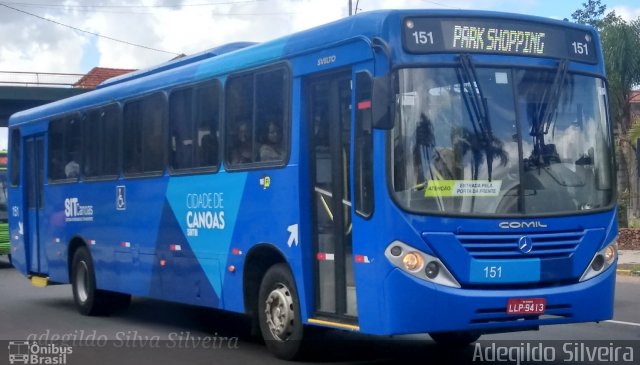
[8,10,617,359]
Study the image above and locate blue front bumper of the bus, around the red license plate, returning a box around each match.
[380,264,616,335]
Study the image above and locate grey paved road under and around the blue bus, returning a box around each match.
[0,257,640,365]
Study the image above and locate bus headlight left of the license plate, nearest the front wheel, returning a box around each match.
[384,241,460,288]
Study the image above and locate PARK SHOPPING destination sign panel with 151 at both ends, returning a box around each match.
[403,17,598,63]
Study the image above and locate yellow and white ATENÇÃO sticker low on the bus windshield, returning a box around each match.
[424,180,502,198]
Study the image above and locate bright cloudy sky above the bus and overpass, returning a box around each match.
[0,0,640,74]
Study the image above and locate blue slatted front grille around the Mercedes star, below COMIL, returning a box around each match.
[456,231,584,260]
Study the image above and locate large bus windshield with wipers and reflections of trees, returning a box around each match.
[391,66,613,216]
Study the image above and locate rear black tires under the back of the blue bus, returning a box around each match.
[70,247,131,316]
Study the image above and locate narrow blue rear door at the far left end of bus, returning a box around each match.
[23,136,47,274]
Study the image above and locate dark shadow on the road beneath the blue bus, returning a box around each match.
[114,299,480,364]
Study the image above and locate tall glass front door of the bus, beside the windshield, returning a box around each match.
[306,70,357,323]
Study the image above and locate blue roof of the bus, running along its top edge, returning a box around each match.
[9,9,597,126]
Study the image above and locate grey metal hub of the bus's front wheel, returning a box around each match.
[264,284,295,341]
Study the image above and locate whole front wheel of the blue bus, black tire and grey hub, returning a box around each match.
[258,264,304,360]
